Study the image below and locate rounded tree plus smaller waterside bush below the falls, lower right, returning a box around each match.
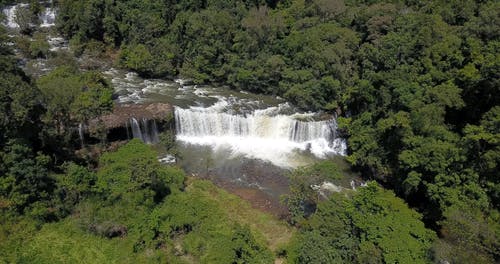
[285,161,437,263]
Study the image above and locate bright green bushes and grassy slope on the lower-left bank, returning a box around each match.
[0,140,280,263]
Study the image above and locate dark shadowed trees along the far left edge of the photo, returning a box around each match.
[0,28,53,221]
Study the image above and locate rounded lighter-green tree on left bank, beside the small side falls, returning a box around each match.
[38,66,113,148]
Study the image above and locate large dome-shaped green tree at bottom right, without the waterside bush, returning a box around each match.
[288,183,436,263]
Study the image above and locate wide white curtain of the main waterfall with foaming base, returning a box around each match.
[175,101,346,167]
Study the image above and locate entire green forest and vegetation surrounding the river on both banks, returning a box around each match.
[0,0,500,263]
